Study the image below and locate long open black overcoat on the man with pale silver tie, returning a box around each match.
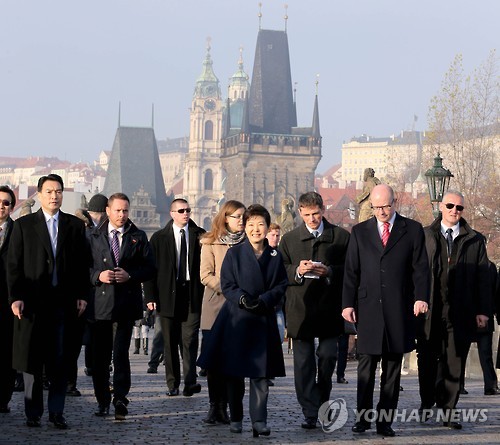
[7,209,90,374]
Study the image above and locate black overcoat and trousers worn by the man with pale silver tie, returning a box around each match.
[7,209,89,417]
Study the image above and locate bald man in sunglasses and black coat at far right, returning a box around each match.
[417,191,492,429]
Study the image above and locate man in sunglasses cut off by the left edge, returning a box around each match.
[0,185,16,413]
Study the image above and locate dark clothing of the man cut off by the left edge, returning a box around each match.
[0,218,16,407]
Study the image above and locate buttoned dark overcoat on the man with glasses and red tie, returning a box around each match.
[342,214,429,355]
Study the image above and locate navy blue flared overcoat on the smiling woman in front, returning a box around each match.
[198,240,288,378]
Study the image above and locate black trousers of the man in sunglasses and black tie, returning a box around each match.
[160,312,200,389]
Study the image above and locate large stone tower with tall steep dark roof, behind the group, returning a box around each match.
[221,29,321,214]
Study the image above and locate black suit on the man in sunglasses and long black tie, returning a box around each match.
[144,220,205,389]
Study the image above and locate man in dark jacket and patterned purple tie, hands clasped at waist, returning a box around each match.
[88,193,155,420]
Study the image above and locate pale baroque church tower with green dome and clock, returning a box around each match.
[183,39,224,230]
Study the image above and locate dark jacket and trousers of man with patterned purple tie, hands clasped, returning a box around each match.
[88,221,155,407]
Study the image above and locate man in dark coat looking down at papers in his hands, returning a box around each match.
[279,192,349,429]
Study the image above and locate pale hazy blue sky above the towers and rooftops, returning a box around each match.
[0,0,500,172]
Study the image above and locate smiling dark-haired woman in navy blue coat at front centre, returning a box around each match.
[198,204,288,437]
